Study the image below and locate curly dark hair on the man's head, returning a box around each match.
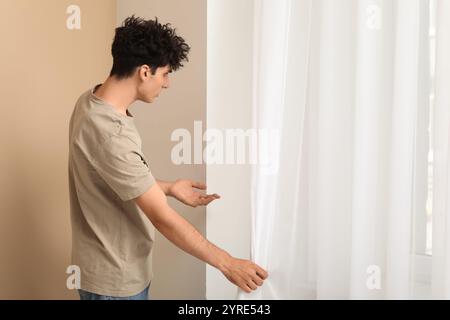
[110,15,190,79]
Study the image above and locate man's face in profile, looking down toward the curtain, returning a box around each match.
[138,66,172,103]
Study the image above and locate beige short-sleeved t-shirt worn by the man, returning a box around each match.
[69,86,155,297]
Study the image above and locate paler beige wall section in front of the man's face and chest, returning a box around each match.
[117,0,207,299]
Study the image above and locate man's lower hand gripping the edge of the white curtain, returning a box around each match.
[220,256,268,293]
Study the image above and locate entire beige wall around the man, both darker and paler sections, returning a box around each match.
[0,0,206,299]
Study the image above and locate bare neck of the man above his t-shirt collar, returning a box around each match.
[94,77,137,115]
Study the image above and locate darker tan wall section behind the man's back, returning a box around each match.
[0,0,116,299]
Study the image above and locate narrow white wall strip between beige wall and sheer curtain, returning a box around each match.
[206,0,253,299]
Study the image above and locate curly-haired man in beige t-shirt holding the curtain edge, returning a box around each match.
[69,16,267,300]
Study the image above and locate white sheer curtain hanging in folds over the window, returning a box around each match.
[239,0,450,299]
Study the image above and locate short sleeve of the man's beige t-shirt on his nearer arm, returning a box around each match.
[93,135,155,201]
